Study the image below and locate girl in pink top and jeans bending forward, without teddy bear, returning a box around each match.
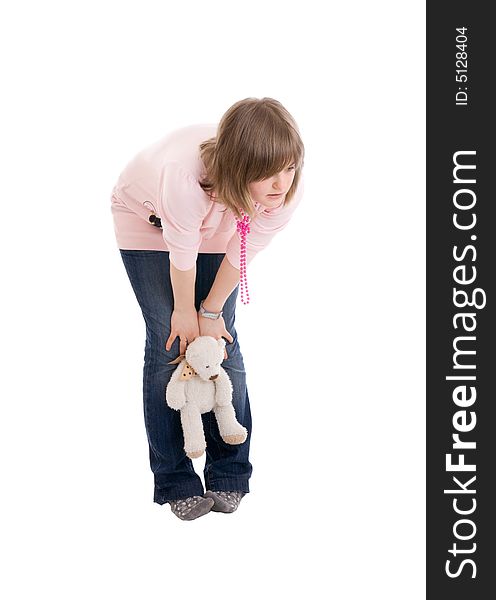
[111,98,304,520]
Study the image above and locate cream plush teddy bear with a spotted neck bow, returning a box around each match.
[165,335,248,458]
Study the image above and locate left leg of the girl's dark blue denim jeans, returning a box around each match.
[120,249,204,504]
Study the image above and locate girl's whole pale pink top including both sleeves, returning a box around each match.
[111,124,303,271]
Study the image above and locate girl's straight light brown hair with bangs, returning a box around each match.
[199,98,305,219]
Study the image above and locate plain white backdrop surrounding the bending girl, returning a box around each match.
[0,0,425,600]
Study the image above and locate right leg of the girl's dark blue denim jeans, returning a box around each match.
[196,254,253,493]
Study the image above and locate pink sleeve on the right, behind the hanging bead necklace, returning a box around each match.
[226,174,304,269]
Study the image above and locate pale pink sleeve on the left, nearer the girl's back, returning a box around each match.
[160,162,210,271]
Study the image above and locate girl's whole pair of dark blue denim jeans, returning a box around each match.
[119,249,252,504]
